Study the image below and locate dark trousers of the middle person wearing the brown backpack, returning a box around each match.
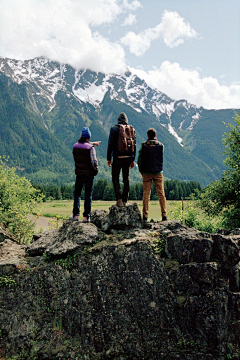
[112,158,132,202]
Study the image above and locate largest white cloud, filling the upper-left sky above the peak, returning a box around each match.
[0,0,141,72]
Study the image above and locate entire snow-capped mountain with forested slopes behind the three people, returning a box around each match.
[0,58,238,185]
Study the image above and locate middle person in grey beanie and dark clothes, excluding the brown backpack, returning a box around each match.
[107,113,136,207]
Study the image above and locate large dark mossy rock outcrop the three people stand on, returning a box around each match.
[0,205,240,360]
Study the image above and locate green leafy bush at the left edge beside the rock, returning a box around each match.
[0,157,42,243]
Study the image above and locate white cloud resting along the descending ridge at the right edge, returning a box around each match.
[131,61,240,109]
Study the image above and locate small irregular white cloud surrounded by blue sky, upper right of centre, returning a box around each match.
[121,11,197,56]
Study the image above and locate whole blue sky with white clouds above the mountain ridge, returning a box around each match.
[0,0,240,109]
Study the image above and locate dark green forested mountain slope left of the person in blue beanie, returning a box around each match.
[0,74,73,183]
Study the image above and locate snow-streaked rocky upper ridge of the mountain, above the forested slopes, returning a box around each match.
[0,58,202,144]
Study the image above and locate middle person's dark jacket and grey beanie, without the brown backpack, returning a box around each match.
[107,113,136,161]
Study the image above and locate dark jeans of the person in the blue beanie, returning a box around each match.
[73,175,94,218]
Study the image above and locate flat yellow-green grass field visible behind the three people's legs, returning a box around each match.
[39,200,180,220]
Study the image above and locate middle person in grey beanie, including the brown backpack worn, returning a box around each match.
[107,112,136,207]
